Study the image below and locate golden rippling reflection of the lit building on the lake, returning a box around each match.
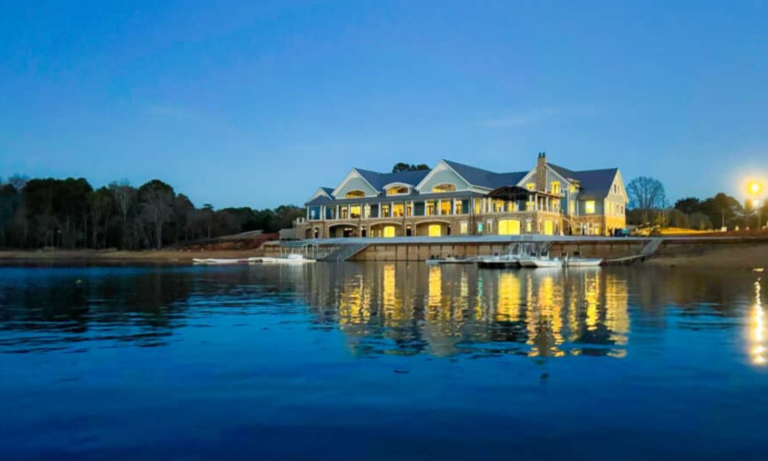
[306,263,630,358]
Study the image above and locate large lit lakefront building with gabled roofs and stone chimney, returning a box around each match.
[296,153,628,239]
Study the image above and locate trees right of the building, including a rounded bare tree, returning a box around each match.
[627,176,768,230]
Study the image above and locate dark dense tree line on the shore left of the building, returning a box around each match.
[0,175,304,250]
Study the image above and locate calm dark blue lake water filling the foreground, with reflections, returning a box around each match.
[0,263,768,461]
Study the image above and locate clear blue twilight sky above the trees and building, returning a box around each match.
[0,0,768,207]
